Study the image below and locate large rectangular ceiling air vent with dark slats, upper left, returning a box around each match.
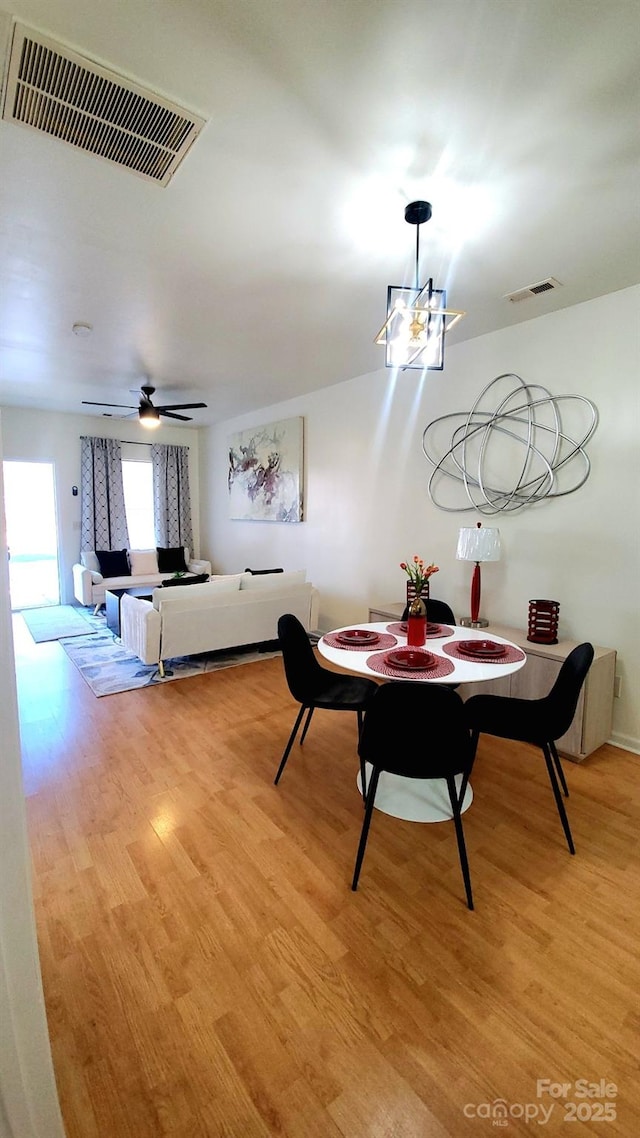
[2,24,205,185]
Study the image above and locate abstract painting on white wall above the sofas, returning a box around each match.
[228,417,303,521]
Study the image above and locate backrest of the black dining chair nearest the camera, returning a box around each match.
[358,681,473,778]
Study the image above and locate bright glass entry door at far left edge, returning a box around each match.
[3,461,60,611]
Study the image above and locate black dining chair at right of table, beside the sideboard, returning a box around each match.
[457,643,593,854]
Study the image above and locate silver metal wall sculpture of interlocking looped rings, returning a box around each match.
[422,372,598,514]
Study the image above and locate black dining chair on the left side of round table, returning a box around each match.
[273,612,378,785]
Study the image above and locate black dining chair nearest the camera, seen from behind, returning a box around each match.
[351,681,474,909]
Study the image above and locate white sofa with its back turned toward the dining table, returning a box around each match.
[121,569,319,675]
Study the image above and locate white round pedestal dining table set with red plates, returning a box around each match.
[318,620,526,822]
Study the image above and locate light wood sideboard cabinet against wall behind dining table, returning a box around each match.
[369,602,616,762]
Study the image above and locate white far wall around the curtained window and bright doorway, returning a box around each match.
[2,407,199,604]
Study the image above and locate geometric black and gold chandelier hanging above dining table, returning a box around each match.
[375,201,466,371]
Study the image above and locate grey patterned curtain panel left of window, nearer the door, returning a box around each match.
[80,435,129,550]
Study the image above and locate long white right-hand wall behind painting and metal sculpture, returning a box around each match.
[200,287,640,750]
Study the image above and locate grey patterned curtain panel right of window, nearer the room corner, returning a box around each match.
[151,443,194,553]
